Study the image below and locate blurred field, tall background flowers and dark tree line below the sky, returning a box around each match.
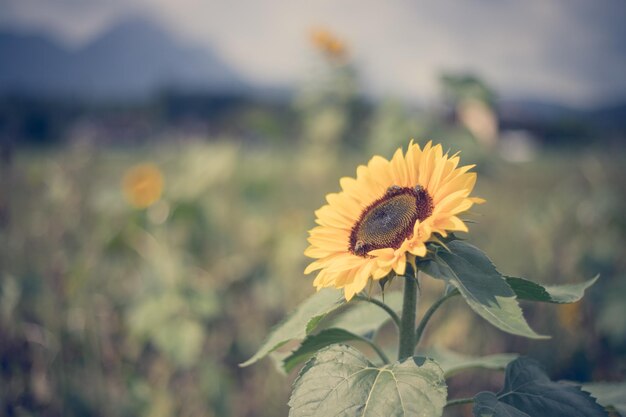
[0,25,626,417]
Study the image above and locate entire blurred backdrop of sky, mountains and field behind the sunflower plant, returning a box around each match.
[0,0,626,417]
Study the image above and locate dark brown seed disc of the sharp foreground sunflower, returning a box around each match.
[349,185,433,257]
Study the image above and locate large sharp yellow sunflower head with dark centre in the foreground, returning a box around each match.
[304,141,484,300]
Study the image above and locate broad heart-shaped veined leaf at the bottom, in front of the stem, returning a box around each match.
[289,345,447,417]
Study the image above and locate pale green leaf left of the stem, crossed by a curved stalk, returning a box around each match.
[322,291,402,335]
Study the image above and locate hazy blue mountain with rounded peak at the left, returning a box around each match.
[0,18,248,99]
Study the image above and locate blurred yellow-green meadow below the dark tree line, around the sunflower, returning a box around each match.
[0,138,626,417]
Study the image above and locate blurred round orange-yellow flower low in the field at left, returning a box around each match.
[122,163,163,209]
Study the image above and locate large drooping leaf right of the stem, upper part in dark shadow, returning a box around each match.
[419,240,547,339]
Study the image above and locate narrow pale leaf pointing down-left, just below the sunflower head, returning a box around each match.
[239,289,345,367]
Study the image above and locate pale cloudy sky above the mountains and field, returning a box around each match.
[0,0,626,107]
